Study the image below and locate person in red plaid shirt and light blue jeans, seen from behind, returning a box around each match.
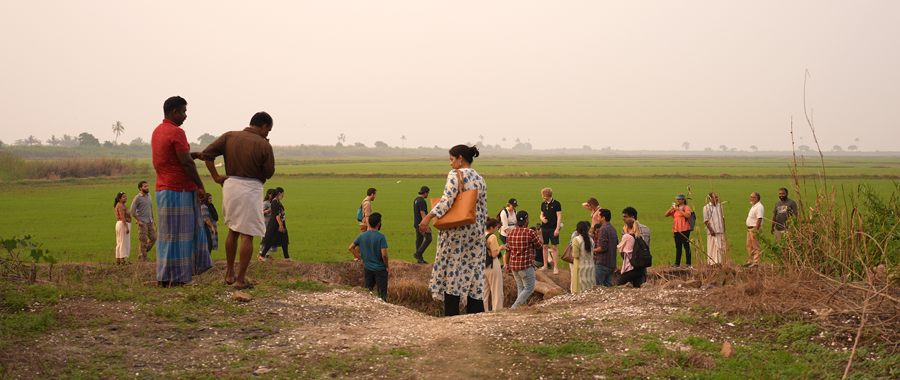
[503,211,543,309]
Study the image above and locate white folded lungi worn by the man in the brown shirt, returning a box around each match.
[222,176,266,236]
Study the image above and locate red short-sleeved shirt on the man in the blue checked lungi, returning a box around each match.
[150,119,197,192]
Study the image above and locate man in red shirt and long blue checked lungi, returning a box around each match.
[150,96,212,287]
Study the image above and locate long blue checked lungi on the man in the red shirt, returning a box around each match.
[156,190,212,283]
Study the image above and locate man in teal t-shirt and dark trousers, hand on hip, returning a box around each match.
[350,212,388,302]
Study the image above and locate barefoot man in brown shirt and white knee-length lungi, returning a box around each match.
[201,112,275,289]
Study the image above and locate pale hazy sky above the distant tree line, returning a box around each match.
[0,0,900,151]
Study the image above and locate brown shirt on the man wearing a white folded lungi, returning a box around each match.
[202,127,275,183]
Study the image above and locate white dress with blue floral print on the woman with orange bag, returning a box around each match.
[428,169,487,305]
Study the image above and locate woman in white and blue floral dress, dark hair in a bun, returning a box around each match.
[419,145,487,316]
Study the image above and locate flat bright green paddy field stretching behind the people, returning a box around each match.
[0,157,900,265]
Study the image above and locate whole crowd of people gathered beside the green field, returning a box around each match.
[115,96,797,316]
